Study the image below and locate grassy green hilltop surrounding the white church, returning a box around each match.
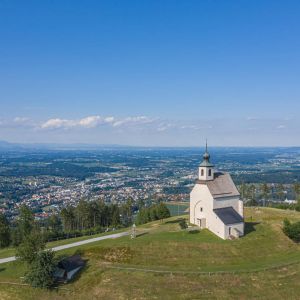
[0,208,300,299]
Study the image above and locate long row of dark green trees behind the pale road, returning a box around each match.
[0,200,133,248]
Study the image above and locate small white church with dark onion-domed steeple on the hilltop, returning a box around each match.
[190,144,244,239]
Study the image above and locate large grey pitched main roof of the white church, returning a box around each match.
[198,172,240,198]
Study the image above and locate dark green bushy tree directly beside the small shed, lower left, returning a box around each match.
[25,250,56,288]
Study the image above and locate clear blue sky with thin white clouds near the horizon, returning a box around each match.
[0,0,300,146]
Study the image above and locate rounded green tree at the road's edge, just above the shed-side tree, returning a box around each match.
[16,231,46,264]
